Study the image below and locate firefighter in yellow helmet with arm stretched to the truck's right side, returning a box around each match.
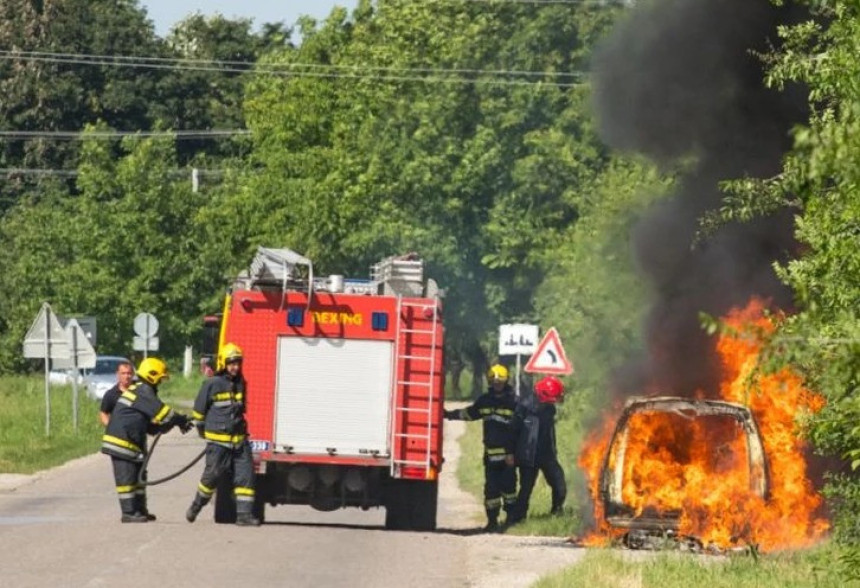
[445,364,517,532]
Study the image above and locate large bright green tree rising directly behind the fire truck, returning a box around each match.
[237,0,610,396]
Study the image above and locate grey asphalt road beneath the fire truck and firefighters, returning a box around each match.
[0,423,578,588]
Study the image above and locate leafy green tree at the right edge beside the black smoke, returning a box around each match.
[723,1,860,543]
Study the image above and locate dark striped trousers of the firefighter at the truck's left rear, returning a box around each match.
[194,441,254,513]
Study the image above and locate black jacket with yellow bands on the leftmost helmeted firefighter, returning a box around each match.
[102,382,186,461]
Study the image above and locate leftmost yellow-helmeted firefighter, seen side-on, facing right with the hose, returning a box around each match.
[102,357,191,523]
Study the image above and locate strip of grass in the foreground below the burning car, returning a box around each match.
[535,545,858,588]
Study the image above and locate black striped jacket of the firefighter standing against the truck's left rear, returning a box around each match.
[191,372,248,447]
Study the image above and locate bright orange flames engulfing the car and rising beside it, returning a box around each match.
[579,299,829,550]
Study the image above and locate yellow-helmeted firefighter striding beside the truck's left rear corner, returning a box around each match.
[185,343,260,526]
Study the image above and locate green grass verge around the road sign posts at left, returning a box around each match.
[0,375,202,474]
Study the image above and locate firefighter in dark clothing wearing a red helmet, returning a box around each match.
[508,376,567,523]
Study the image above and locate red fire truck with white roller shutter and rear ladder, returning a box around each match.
[215,247,444,530]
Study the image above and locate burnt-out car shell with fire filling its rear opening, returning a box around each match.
[600,396,769,548]
